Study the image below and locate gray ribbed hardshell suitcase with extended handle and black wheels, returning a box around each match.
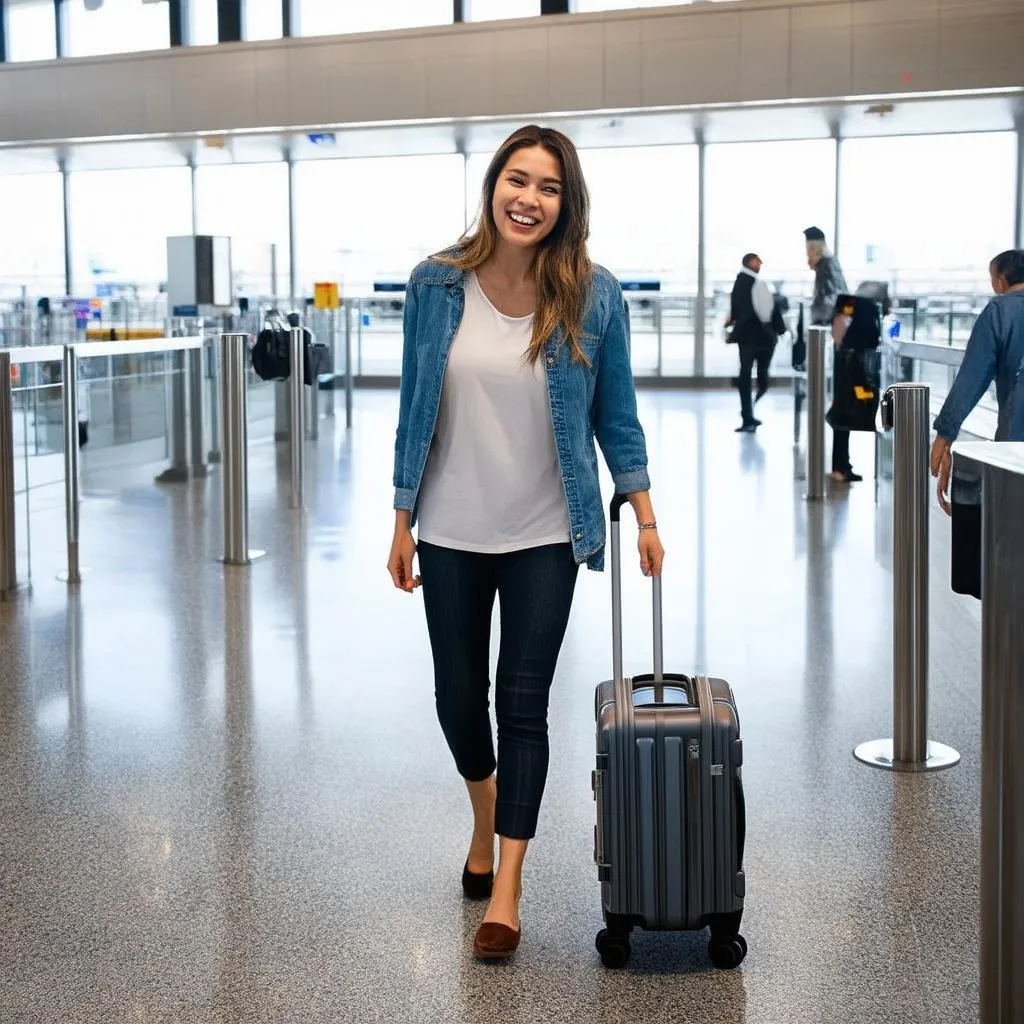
[593,495,746,968]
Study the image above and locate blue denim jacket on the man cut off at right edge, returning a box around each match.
[935,292,1024,441]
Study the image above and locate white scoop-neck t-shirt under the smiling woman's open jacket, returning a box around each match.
[419,273,569,554]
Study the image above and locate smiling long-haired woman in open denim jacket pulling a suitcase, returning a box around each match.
[388,125,665,958]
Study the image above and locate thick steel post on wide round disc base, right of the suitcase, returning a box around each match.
[853,384,959,771]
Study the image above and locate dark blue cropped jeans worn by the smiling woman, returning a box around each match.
[419,543,579,839]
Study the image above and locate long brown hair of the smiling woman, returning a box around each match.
[436,125,593,366]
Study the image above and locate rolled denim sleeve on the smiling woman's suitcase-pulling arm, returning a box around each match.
[593,282,650,495]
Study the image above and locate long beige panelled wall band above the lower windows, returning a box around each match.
[0,0,1024,141]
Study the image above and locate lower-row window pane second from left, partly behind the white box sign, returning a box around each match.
[70,167,191,296]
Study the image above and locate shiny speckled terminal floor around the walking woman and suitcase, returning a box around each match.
[0,391,980,1024]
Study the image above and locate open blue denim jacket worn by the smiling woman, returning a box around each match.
[394,260,650,569]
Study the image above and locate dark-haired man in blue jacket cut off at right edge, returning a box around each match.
[932,249,1024,514]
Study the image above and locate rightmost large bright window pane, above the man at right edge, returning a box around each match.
[839,132,1017,293]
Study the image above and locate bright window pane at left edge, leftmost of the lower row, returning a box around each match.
[0,171,65,297]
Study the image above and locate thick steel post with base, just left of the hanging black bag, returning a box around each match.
[220,334,264,565]
